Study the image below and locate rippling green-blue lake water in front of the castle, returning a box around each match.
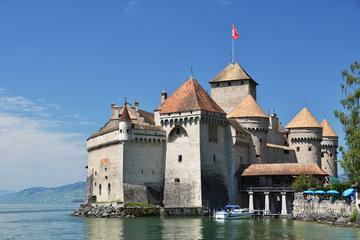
[0,204,360,240]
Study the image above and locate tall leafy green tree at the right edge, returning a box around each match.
[335,62,360,182]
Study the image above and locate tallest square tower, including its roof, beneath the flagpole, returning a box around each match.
[209,63,258,113]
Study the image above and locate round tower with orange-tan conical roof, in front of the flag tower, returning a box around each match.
[227,95,269,163]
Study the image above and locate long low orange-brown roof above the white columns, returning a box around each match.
[238,163,328,177]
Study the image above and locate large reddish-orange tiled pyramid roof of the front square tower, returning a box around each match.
[160,77,225,114]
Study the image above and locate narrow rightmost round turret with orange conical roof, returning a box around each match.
[321,119,338,177]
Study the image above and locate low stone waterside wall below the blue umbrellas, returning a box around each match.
[292,193,356,222]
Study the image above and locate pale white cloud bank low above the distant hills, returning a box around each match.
[0,113,87,190]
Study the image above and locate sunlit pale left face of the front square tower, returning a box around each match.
[163,115,202,208]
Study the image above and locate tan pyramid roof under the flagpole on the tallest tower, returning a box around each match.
[209,63,256,83]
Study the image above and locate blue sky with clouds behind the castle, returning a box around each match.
[0,0,360,189]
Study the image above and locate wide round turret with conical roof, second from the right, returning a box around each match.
[286,107,322,166]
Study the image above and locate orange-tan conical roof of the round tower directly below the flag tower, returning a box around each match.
[227,95,268,118]
